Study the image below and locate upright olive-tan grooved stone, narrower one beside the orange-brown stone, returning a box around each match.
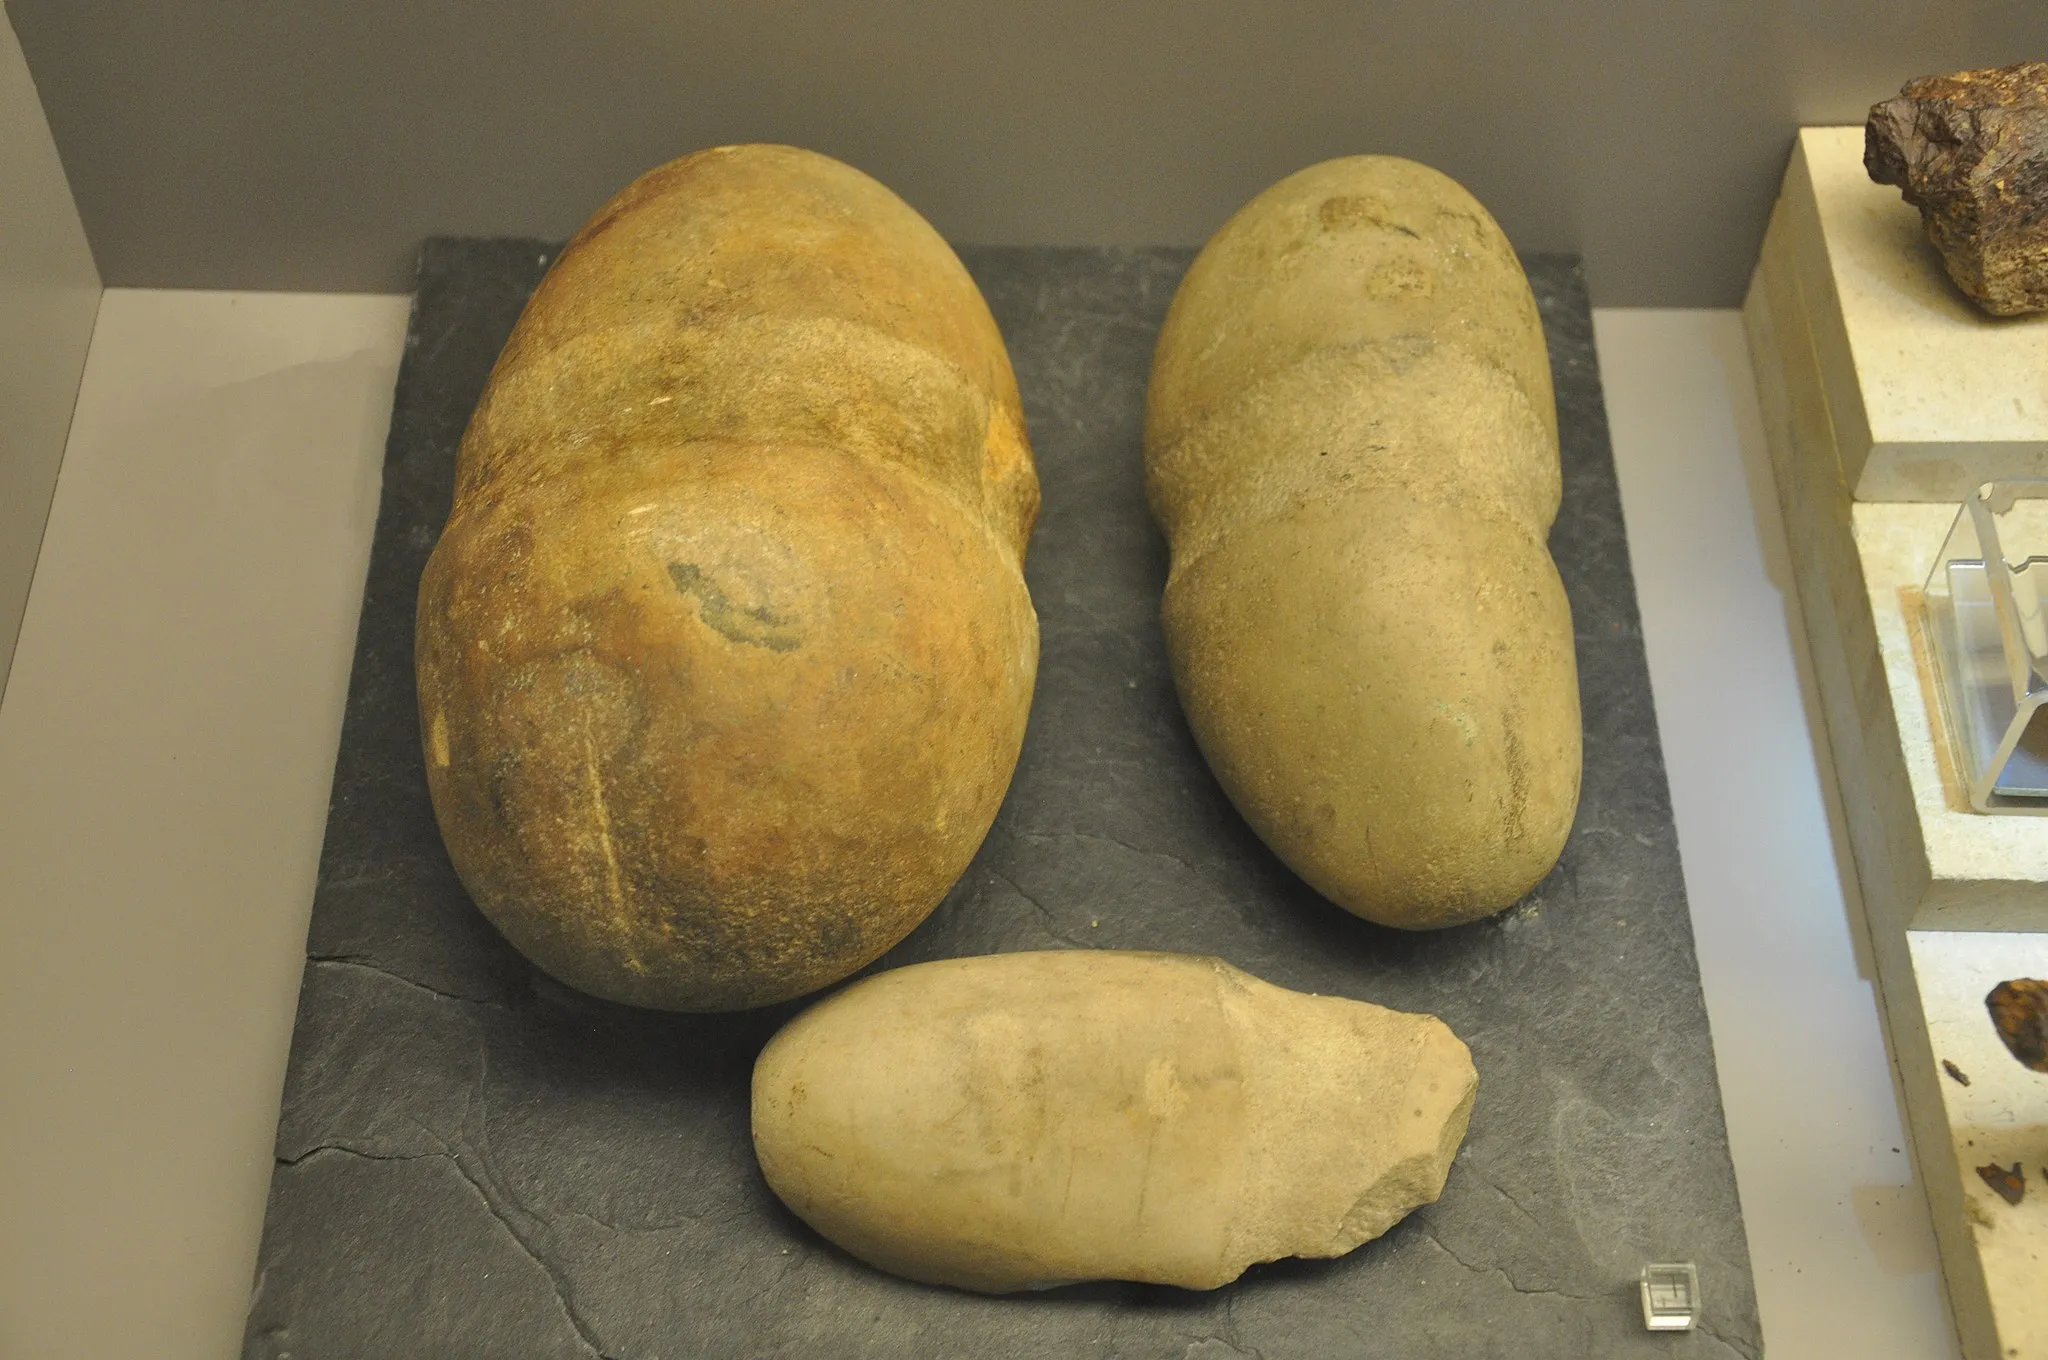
[1145,156,1579,928]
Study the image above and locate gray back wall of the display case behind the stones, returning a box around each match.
[12,0,2048,307]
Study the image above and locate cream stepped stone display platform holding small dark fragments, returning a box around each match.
[1743,127,2048,1360]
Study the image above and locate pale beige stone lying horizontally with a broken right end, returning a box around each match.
[754,950,1479,1292]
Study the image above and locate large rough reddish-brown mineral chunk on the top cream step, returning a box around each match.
[1864,61,2048,315]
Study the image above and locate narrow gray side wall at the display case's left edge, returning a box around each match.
[0,0,100,694]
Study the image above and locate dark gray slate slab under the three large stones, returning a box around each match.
[246,242,1761,1360]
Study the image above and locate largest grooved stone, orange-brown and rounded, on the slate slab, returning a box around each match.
[418,145,1038,1010]
